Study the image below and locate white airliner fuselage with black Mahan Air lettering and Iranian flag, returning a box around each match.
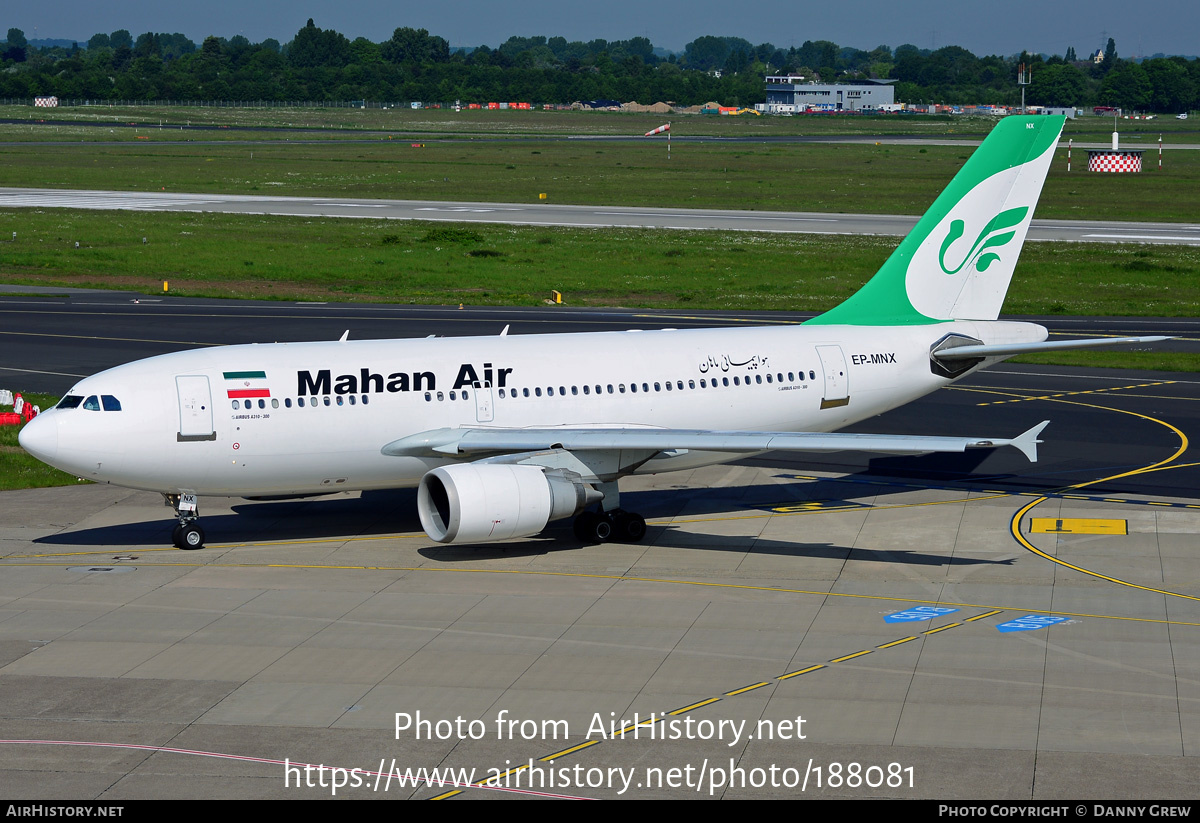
[22,320,1045,497]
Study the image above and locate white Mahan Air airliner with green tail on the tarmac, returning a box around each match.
[20,116,1166,548]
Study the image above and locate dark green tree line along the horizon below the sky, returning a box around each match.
[0,19,1200,113]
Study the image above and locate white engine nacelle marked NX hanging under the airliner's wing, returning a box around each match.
[416,463,602,543]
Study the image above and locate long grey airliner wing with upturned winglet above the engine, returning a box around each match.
[382,420,1050,463]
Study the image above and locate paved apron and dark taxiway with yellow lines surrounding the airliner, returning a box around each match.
[0,294,1200,801]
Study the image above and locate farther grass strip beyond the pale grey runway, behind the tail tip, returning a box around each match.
[7,140,1200,221]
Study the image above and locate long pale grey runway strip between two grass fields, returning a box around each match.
[0,188,1200,246]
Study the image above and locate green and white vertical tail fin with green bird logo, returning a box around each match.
[809,116,1066,325]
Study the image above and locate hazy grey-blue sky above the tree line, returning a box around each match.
[9,0,1200,58]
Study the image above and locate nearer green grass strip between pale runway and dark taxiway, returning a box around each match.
[0,210,1200,317]
